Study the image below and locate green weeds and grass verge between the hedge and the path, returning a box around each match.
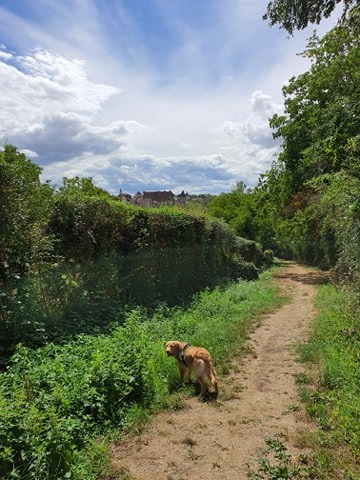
[0,272,281,480]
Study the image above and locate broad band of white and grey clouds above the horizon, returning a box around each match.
[0,41,286,193]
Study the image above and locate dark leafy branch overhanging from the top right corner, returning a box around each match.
[263,0,359,35]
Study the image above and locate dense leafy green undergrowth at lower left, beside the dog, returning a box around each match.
[0,317,160,479]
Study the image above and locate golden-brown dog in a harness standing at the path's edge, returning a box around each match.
[165,340,218,400]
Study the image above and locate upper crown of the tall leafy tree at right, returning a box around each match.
[270,7,360,195]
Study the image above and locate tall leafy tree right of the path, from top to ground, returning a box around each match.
[255,6,360,271]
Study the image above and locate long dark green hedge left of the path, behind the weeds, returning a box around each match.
[0,145,271,363]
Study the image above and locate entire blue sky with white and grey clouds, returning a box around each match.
[0,0,335,195]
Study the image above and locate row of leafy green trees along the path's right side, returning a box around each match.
[209,2,360,297]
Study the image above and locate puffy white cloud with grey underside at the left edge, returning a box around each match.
[0,49,124,164]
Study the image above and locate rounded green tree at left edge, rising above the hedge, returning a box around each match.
[0,145,52,282]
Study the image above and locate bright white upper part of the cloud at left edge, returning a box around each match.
[0,48,120,124]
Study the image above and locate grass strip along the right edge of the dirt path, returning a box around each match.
[300,285,360,480]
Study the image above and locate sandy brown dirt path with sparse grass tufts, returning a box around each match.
[112,263,324,480]
